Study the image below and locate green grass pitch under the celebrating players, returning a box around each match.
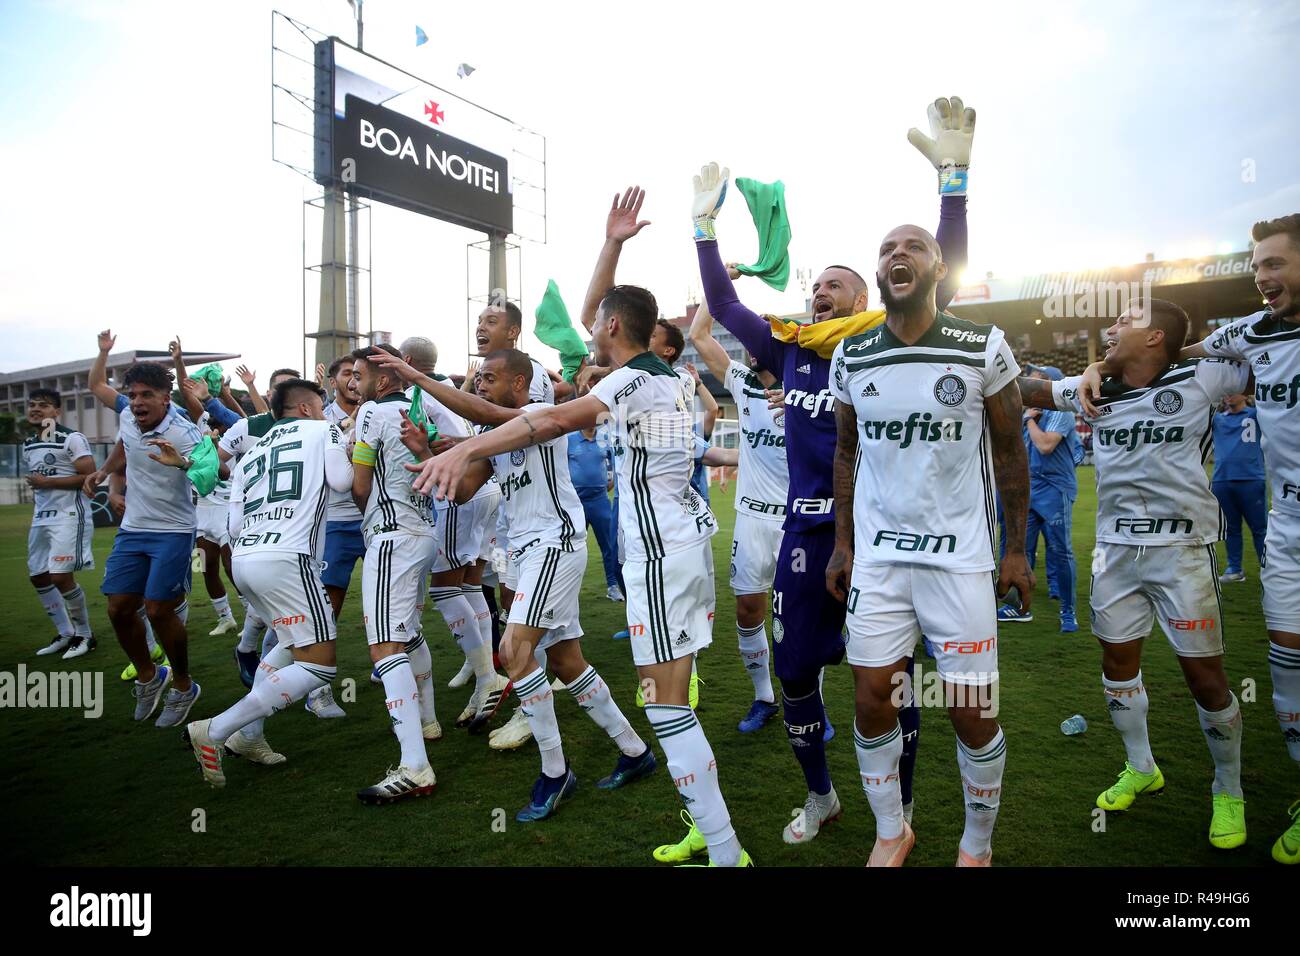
[0,468,1300,866]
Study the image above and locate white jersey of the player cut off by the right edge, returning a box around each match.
[1201,310,1300,514]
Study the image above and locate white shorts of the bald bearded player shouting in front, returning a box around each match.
[845,563,997,687]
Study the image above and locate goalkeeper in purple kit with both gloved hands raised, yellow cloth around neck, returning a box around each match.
[693,96,975,843]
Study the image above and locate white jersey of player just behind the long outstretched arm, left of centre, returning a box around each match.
[475,402,586,557]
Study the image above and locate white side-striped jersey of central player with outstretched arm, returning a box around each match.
[590,352,718,561]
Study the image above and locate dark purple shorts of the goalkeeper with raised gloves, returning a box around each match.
[772,524,845,682]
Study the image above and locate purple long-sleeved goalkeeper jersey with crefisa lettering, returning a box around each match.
[696,196,966,531]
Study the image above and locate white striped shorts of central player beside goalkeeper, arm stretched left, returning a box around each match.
[623,538,715,667]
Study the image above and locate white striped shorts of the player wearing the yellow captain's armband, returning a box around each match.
[361,533,438,645]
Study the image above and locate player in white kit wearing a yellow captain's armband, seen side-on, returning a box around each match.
[352,345,442,804]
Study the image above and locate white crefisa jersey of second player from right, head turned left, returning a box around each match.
[1052,359,1249,545]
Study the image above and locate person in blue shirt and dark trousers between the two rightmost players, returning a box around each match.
[1210,395,1269,584]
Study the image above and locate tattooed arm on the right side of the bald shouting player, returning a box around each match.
[982,378,1034,610]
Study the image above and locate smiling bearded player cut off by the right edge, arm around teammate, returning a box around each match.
[1080,213,1300,865]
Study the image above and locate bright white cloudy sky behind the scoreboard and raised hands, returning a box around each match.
[0,0,1300,385]
